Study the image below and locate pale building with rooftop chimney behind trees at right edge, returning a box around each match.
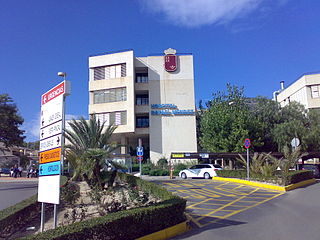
[273,73,320,109]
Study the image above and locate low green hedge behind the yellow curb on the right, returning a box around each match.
[216,170,313,186]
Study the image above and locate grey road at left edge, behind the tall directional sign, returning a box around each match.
[0,177,38,210]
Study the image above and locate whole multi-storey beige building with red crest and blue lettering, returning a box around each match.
[89,49,197,162]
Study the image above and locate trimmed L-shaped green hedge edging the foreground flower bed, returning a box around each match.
[19,173,186,240]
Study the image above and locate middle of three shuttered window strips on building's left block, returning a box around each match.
[93,87,127,104]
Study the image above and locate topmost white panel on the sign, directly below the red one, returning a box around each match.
[40,95,63,128]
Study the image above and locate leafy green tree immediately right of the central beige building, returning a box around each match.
[200,84,255,152]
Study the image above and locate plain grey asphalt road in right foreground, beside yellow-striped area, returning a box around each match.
[168,180,320,240]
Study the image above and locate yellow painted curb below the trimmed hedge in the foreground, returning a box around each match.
[136,221,189,240]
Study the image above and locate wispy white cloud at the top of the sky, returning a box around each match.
[142,0,264,27]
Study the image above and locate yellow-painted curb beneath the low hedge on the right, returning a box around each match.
[212,177,317,192]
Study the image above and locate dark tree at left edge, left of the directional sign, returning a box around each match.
[0,94,25,147]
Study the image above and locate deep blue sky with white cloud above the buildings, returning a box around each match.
[0,0,320,141]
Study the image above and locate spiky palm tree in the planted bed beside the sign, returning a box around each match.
[65,115,120,188]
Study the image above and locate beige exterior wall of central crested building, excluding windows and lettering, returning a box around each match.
[89,51,197,163]
